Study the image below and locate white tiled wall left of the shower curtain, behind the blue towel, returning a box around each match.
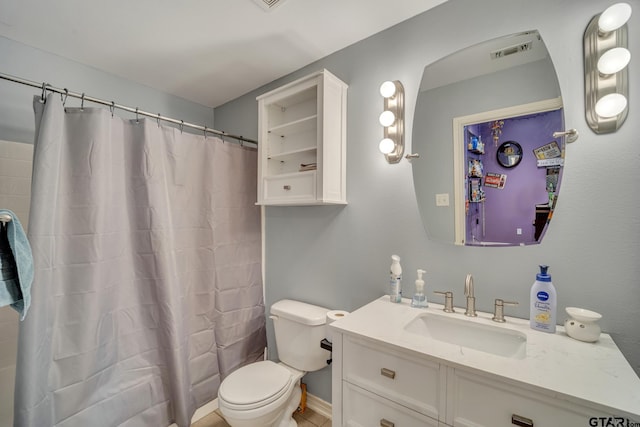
[0,140,33,427]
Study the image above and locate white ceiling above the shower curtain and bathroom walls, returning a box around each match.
[0,0,446,107]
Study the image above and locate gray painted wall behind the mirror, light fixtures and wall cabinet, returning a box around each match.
[215,0,640,401]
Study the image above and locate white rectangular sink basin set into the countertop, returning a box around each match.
[405,313,527,359]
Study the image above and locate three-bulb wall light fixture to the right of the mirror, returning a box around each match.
[584,3,631,133]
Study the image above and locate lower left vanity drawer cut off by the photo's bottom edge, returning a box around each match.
[342,382,438,427]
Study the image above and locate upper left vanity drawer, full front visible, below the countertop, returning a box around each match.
[343,337,446,419]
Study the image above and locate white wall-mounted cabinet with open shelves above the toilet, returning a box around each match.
[257,70,347,205]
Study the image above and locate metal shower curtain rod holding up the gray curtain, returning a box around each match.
[0,73,258,145]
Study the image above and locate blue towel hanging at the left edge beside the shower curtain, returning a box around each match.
[0,209,33,320]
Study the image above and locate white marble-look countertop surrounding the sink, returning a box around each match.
[330,296,640,419]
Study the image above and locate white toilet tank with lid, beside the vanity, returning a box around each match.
[271,299,331,372]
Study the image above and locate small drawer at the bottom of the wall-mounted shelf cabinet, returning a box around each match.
[263,171,316,203]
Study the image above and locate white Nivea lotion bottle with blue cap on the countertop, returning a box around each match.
[529,265,557,333]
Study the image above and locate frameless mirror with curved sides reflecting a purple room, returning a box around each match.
[412,31,564,246]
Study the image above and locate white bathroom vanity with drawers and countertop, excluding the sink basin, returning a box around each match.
[329,296,640,427]
